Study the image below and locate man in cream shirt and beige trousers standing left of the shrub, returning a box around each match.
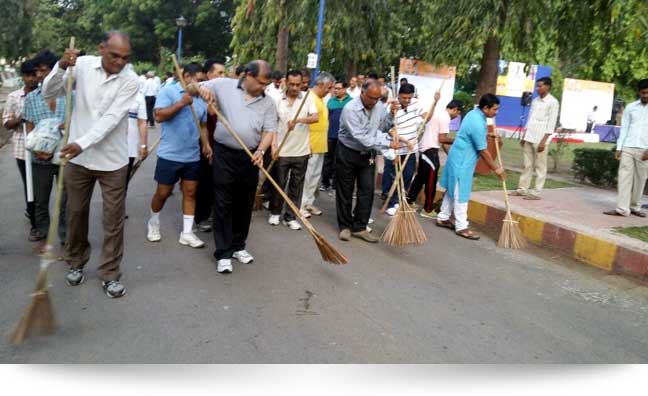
[511,77,560,200]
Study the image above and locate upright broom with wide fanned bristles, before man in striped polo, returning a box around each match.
[381,66,427,247]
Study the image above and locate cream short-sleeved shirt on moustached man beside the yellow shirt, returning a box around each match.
[276,92,317,157]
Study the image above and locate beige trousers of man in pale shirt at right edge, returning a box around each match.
[616,148,648,216]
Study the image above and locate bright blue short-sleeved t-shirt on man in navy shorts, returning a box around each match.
[155,84,207,163]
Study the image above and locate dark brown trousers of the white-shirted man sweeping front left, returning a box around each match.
[64,163,128,281]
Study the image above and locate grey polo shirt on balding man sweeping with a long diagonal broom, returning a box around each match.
[202,78,277,150]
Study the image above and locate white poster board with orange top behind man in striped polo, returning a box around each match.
[398,58,457,111]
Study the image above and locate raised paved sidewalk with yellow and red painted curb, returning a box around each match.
[468,187,648,282]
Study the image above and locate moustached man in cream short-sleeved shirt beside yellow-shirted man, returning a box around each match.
[268,70,319,231]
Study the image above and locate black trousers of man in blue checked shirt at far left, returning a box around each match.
[32,163,67,241]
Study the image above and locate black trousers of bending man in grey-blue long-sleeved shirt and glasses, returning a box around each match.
[335,142,376,232]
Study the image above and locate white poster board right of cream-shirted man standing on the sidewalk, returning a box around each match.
[560,78,614,131]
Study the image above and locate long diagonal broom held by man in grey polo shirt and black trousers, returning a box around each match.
[173,57,349,264]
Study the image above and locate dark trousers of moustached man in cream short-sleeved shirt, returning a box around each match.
[270,155,309,221]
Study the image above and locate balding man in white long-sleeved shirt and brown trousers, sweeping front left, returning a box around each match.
[43,31,139,298]
